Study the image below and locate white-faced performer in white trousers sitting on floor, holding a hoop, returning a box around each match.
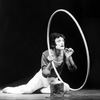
[2,33,77,94]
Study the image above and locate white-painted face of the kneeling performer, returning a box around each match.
[55,37,65,50]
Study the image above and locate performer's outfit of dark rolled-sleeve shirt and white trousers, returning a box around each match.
[2,48,76,94]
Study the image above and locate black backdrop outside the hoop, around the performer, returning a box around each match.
[0,0,100,89]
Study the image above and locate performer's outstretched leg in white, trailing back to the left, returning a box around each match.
[3,71,43,94]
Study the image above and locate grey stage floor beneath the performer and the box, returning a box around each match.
[0,89,100,100]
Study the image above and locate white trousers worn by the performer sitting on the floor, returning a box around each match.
[3,69,69,94]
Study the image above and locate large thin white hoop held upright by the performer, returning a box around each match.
[47,9,90,91]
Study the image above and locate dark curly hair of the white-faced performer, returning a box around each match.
[50,32,65,49]
